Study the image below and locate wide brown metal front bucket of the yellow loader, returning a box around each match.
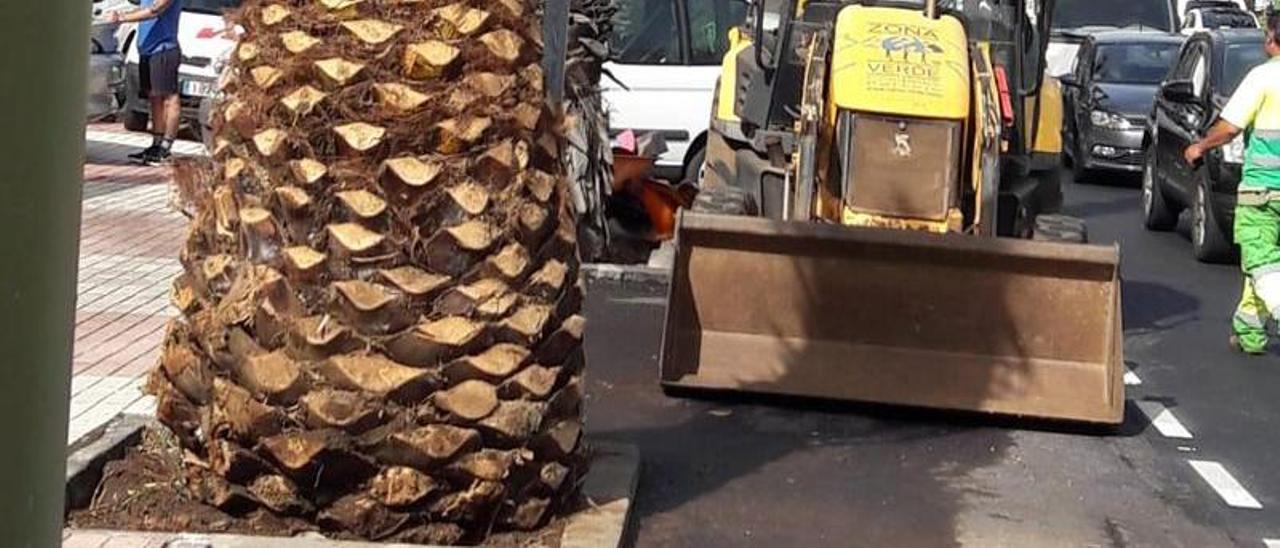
[660,213,1124,424]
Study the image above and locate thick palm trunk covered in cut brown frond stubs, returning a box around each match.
[150,0,584,543]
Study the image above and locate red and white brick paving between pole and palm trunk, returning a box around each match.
[67,124,201,443]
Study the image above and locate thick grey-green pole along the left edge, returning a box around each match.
[0,0,91,548]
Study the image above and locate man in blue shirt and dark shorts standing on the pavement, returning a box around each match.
[111,0,182,165]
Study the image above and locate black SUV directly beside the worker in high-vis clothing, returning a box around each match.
[1142,29,1267,262]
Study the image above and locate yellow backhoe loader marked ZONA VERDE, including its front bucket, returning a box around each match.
[660,0,1124,424]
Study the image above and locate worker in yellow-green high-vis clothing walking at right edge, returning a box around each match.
[1184,9,1280,355]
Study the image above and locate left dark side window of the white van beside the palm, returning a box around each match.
[611,0,684,65]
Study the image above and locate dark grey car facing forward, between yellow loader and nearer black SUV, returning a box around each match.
[1061,31,1184,181]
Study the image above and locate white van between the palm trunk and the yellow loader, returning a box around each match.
[602,0,746,181]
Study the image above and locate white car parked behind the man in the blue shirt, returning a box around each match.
[120,0,239,140]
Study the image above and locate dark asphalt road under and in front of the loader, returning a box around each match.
[588,169,1280,547]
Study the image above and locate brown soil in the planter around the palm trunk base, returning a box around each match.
[68,428,564,547]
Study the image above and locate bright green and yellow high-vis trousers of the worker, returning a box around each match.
[1231,198,1280,353]
